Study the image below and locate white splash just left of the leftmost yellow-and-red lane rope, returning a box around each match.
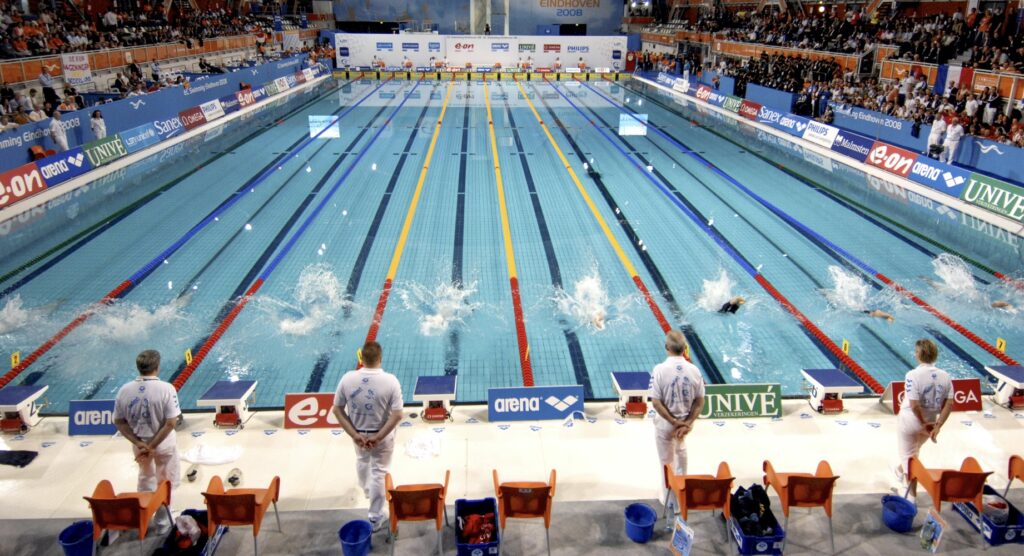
[276,263,346,336]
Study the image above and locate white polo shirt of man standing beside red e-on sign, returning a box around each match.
[334,369,404,433]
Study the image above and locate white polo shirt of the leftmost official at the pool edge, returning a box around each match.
[114,377,181,446]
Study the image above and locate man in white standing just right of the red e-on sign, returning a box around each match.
[332,341,403,530]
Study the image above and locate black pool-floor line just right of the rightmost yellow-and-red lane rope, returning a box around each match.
[532,85,725,384]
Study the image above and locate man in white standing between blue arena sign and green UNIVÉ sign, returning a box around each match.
[650,330,705,474]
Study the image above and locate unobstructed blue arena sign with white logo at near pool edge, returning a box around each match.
[487,385,583,422]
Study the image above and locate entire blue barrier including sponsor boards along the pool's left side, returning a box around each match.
[0,62,323,218]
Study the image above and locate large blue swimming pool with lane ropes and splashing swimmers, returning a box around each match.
[0,76,1024,412]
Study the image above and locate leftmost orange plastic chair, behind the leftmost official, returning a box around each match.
[82,479,171,554]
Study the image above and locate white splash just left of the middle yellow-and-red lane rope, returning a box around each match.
[397,282,480,336]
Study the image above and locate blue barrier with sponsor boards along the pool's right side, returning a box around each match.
[656,73,1024,222]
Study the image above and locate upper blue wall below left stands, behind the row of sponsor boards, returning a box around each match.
[0,56,305,175]
